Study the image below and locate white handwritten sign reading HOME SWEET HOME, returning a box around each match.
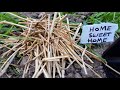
[80,23,118,44]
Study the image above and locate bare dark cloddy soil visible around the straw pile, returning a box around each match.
[2,12,111,78]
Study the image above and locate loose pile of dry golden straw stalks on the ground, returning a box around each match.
[0,12,119,78]
